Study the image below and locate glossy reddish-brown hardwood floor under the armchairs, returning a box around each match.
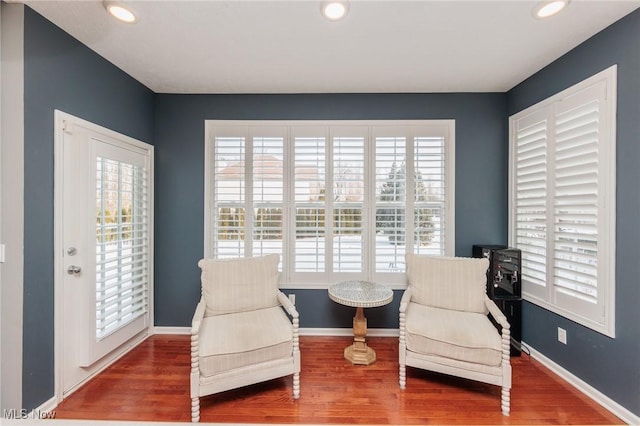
[55,335,624,425]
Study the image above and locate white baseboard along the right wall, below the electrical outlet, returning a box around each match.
[522,342,640,425]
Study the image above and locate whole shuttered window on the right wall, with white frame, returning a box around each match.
[510,67,616,337]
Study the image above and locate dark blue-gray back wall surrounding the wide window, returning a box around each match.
[154,93,507,328]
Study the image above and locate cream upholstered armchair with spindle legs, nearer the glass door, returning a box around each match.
[191,254,300,422]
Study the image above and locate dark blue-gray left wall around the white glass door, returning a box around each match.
[22,7,154,409]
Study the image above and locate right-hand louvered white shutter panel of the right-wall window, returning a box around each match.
[553,90,606,317]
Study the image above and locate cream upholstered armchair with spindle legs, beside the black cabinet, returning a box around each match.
[400,254,511,415]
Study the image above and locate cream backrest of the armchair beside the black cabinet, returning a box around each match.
[405,253,489,314]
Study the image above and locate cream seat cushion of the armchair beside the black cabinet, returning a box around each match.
[406,302,502,366]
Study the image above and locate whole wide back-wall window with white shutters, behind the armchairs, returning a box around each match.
[205,120,454,287]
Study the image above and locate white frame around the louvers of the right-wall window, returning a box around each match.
[509,65,617,338]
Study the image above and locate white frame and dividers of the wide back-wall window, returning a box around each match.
[204,120,455,289]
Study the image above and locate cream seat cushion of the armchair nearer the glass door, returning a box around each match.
[199,306,293,377]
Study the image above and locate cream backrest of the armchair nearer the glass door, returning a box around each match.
[198,254,280,316]
